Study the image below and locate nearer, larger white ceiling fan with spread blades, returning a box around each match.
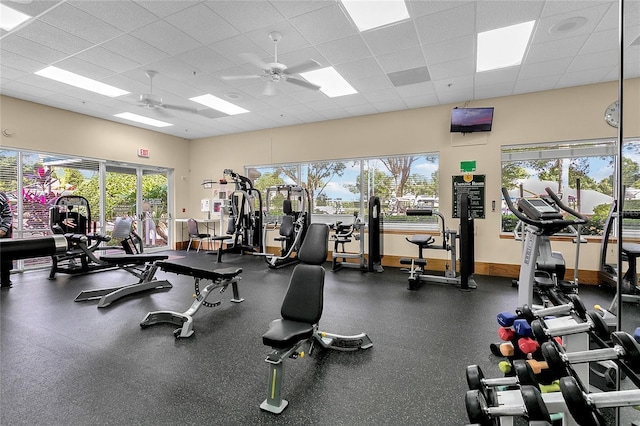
[222,31,322,95]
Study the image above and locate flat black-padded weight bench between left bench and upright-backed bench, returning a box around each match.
[140,261,244,339]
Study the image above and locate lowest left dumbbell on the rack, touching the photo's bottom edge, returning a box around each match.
[465,385,551,426]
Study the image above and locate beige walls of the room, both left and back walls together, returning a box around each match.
[1,79,640,280]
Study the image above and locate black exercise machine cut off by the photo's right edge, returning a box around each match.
[598,200,640,312]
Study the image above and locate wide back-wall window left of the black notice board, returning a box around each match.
[246,154,438,223]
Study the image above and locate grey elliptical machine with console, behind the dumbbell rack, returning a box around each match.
[502,187,588,307]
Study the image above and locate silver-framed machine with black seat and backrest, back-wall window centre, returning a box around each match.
[253,185,311,269]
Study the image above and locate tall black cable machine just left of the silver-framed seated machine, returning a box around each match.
[219,169,262,253]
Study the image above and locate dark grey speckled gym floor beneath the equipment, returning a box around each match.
[0,251,638,426]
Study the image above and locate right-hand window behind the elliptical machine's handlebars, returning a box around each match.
[502,139,640,235]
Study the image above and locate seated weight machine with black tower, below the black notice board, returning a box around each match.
[400,194,478,291]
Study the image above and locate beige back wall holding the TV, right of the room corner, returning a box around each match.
[190,79,640,280]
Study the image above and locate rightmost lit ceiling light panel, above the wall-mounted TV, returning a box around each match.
[476,21,536,72]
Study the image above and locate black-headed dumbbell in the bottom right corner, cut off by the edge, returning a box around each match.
[560,376,640,426]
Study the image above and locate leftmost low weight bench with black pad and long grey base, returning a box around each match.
[75,253,172,308]
